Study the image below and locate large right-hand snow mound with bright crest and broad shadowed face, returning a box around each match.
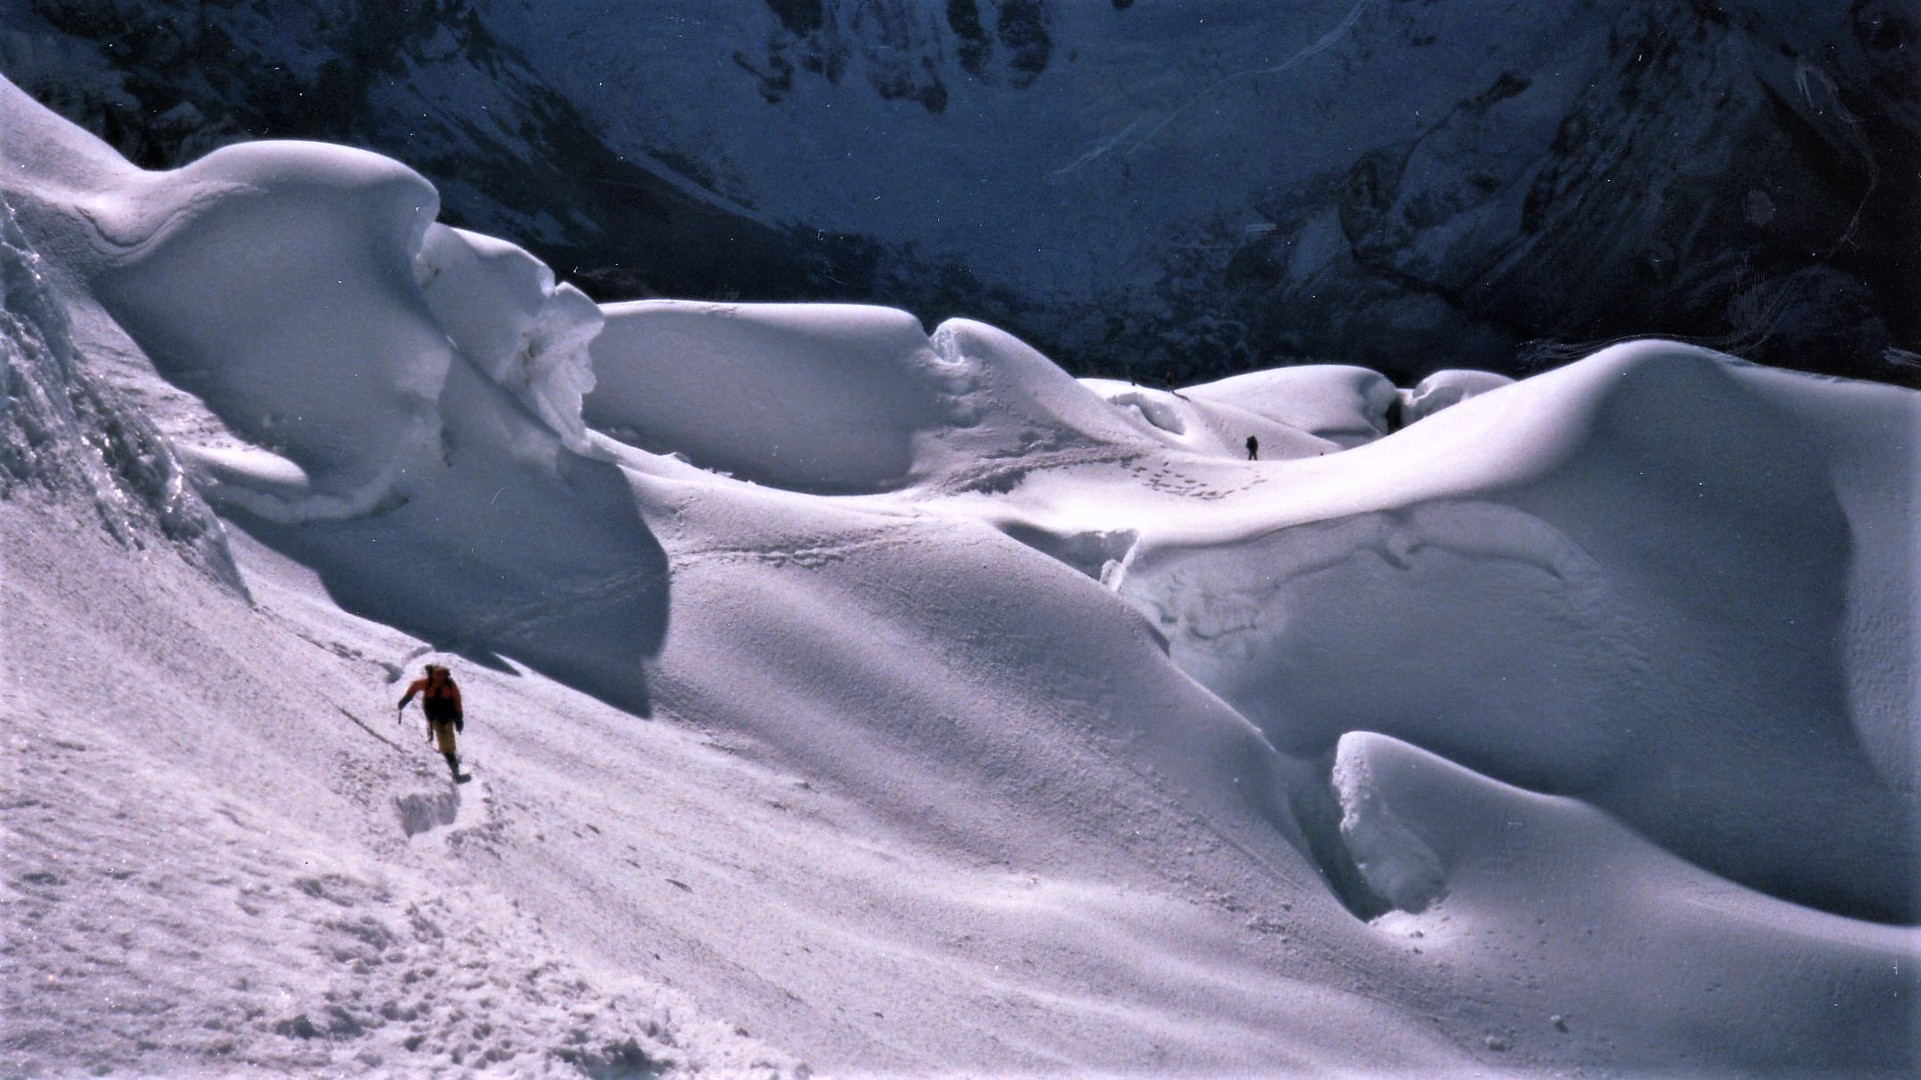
[1120,342,1917,920]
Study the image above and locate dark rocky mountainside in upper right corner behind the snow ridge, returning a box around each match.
[1075,0,1921,384]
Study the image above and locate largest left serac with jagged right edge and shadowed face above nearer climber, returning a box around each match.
[6,88,667,713]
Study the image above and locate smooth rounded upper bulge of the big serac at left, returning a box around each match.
[79,142,455,521]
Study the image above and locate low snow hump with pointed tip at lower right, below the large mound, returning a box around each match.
[1333,732,1915,1074]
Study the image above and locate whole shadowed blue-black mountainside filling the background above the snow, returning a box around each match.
[0,0,1921,382]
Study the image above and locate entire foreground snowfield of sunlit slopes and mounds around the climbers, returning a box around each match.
[0,71,1921,1076]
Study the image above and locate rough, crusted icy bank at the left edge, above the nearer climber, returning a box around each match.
[0,189,244,592]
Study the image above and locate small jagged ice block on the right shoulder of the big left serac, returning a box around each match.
[415,225,605,452]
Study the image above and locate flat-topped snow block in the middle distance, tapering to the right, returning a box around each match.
[586,300,1149,494]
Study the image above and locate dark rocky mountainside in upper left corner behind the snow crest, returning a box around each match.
[0,0,863,307]
